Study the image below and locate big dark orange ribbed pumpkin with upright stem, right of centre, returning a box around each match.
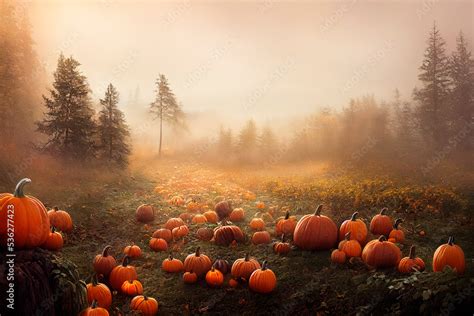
[293,205,337,250]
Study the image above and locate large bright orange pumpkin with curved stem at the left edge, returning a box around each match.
[0,178,50,249]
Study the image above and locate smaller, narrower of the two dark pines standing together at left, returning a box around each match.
[98,84,130,166]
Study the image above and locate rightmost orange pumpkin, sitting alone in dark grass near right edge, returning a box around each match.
[433,237,466,274]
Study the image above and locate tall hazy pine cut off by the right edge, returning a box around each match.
[450,32,474,148]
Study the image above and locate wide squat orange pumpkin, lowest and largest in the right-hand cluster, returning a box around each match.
[362,235,401,268]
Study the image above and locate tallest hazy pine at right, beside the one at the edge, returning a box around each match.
[414,24,450,148]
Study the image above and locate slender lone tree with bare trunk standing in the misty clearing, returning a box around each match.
[150,74,184,156]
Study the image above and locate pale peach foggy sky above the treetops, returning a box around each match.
[29,0,474,127]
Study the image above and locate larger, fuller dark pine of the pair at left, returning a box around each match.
[37,54,96,160]
